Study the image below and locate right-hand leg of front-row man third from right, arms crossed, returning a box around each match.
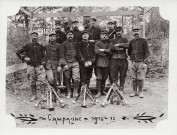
[101,67,110,95]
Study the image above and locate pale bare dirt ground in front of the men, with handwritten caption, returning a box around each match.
[6,77,168,129]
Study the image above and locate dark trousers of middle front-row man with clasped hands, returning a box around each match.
[80,64,93,86]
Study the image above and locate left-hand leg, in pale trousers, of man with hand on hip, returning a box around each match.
[27,65,37,102]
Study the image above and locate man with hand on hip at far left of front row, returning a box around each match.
[16,32,47,102]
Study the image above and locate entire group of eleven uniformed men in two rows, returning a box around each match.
[16,17,149,101]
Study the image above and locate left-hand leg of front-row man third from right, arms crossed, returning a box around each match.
[95,67,103,98]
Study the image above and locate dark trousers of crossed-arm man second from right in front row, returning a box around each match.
[110,59,128,88]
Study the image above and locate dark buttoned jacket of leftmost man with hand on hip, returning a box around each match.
[16,43,45,67]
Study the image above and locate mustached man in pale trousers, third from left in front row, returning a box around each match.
[60,31,80,98]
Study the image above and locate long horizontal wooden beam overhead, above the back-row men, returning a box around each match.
[33,11,143,18]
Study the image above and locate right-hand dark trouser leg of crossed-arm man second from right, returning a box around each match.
[120,59,128,92]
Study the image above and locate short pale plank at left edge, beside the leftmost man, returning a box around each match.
[6,63,27,74]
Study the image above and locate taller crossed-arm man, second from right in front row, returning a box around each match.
[110,27,128,93]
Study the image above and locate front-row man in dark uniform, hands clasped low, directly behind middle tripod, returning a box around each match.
[77,30,95,87]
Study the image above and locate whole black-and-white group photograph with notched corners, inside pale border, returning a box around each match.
[5,6,170,129]
